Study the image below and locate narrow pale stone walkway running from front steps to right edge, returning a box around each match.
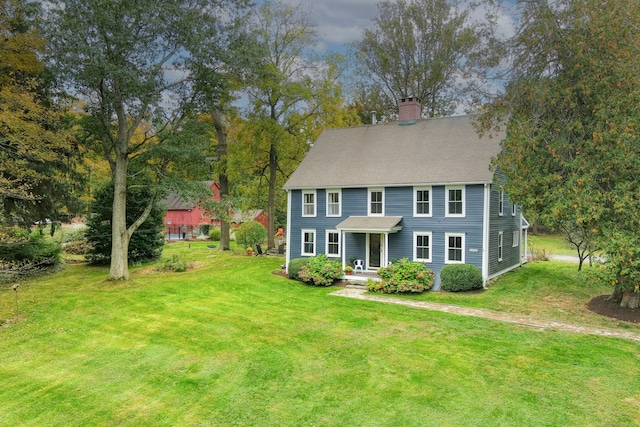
[331,286,640,342]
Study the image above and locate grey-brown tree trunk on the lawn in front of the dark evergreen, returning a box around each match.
[107,152,129,280]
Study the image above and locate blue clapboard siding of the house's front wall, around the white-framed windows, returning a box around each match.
[288,184,488,289]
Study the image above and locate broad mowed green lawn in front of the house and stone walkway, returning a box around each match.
[0,243,640,426]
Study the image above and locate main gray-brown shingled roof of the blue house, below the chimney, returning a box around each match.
[284,116,504,190]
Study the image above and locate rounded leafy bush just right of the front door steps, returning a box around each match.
[367,258,434,294]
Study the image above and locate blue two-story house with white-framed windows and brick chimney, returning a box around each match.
[284,98,528,289]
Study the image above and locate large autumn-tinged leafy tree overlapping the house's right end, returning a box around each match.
[482,0,640,307]
